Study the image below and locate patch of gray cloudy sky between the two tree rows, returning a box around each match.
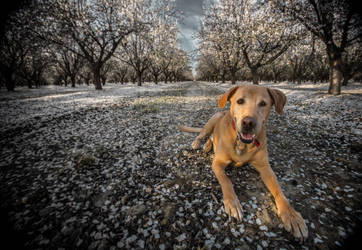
[176,0,203,69]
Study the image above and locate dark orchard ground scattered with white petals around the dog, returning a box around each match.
[0,82,362,249]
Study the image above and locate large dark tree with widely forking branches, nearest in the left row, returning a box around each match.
[33,0,136,90]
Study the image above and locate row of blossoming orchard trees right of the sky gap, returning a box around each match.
[196,0,362,94]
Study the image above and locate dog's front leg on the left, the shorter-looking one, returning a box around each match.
[212,155,243,221]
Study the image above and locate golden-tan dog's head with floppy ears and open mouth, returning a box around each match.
[219,85,287,143]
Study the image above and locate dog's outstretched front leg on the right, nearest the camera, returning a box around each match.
[251,152,308,240]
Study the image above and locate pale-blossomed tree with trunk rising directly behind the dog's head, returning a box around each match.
[240,1,299,84]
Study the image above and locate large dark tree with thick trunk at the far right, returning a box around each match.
[273,0,362,95]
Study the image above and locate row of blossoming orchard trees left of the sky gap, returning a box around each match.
[0,0,192,91]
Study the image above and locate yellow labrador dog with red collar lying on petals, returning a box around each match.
[179,85,308,240]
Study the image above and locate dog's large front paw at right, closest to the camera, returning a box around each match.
[279,205,308,241]
